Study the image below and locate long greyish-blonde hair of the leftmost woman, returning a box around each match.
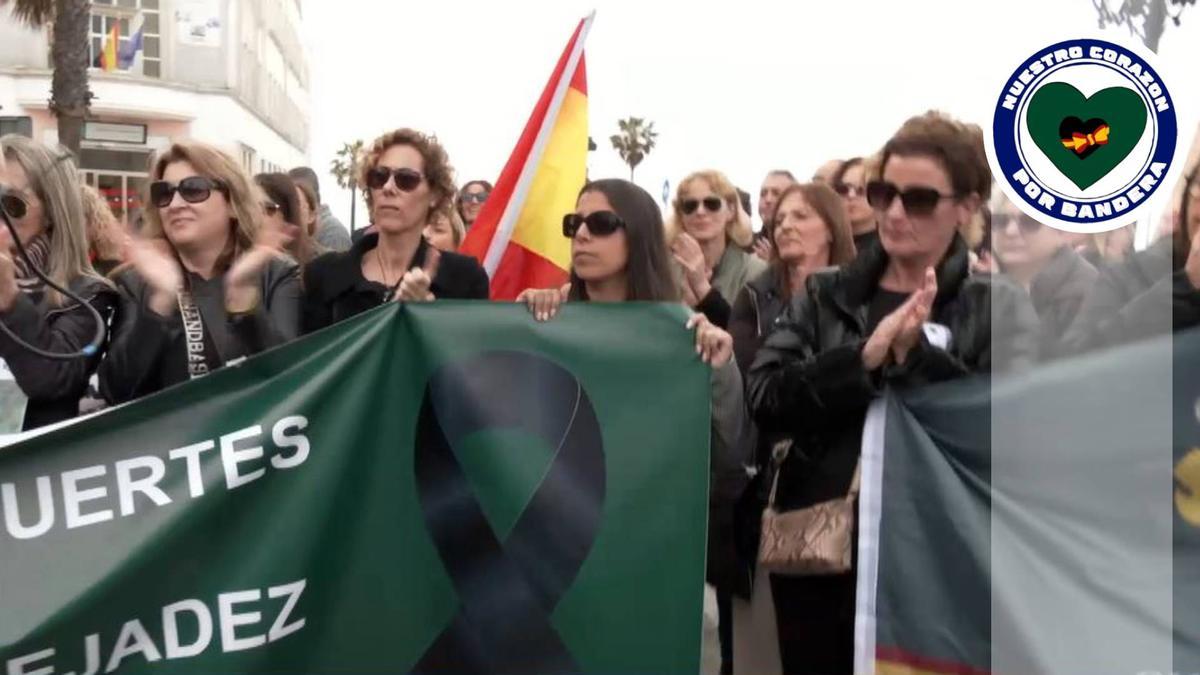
[0,135,102,306]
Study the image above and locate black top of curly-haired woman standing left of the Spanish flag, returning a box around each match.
[304,233,488,333]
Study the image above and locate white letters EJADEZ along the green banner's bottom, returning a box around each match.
[5,579,308,675]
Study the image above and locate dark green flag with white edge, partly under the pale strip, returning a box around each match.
[856,330,1200,675]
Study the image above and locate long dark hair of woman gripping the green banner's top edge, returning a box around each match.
[568,178,679,303]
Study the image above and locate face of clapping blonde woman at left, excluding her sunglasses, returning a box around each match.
[158,160,234,251]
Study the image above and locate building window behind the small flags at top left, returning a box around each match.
[88,0,162,78]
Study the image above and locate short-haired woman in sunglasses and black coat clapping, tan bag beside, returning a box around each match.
[748,113,1037,675]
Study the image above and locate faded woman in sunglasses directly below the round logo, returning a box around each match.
[991,193,1097,359]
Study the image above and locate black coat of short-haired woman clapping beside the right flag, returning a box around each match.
[748,237,1038,510]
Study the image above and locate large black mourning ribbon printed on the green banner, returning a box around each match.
[413,351,605,675]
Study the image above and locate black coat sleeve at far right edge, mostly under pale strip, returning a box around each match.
[1062,239,1200,353]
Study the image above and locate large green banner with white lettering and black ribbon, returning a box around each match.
[0,301,710,675]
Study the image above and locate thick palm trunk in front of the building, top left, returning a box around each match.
[0,0,91,157]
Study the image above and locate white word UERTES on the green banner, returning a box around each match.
[0,416,310,540]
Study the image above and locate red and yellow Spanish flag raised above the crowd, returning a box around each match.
[462,12,595,300]
